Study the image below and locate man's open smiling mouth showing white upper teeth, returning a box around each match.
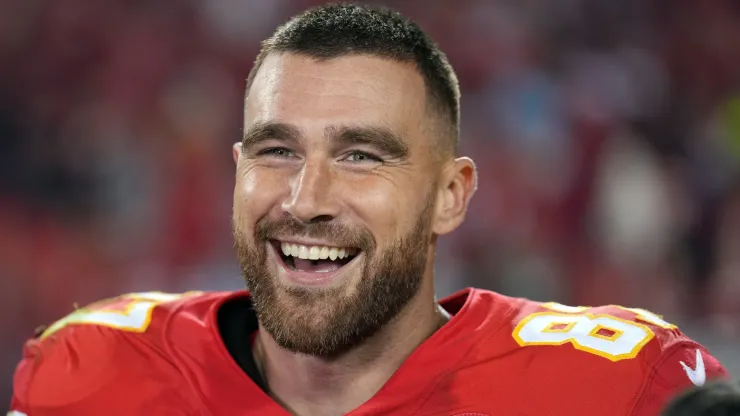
[271,240,360,273]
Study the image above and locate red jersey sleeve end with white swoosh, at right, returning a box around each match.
[631,341,730,416]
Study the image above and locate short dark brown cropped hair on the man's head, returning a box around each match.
[247,4,460,153]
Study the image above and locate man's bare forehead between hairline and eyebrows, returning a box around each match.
[245,53,426,138]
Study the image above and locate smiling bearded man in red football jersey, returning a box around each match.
[12,5,726,416]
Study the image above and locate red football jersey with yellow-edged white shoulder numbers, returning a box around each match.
[11,289,728,416]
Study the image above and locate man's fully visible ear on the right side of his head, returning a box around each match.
[433,157,478,235]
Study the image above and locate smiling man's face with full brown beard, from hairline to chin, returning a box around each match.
[233,54,438,355]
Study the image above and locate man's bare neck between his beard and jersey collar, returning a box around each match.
[254,279,449,416]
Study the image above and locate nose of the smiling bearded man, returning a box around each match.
[282,156,339,223]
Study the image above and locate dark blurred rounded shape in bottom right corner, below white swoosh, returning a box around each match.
[662,381,740,416]
